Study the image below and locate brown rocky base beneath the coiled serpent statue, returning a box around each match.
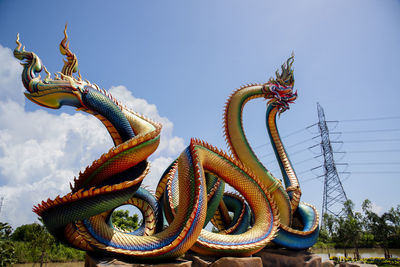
[85,249,322,267]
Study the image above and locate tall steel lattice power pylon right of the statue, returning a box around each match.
[317,103,347,222]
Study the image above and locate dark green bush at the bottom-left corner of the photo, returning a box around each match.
[0,222,17,266]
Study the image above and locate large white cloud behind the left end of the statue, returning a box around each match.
[0,45,184,228]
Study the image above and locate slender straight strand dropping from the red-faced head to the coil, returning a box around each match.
[266,105,301,210]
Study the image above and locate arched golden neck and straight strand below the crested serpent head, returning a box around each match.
[224,85,301,216]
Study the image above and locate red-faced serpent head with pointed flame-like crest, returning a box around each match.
[263,54,297,113]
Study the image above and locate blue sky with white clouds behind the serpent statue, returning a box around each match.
[0,0,400,226]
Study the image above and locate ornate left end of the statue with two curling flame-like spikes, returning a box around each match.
[14,29,135,143]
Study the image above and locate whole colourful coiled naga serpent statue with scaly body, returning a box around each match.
[14,28,319,260]
